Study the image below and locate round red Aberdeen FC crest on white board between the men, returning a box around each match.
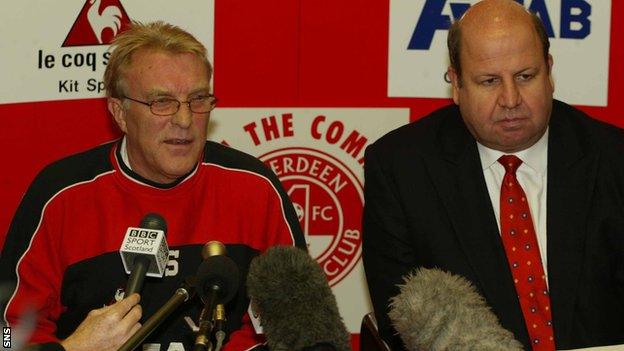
[260,147,363,286]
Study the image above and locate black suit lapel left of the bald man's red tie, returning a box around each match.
[430,111,528,345]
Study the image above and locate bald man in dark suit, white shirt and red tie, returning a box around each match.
[363,0,624,350]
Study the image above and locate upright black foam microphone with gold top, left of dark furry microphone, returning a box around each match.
[194,241,239,351]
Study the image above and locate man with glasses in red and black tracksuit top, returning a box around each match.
[0,22,305,351]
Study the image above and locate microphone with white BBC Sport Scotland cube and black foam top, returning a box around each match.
[119,213,169,296]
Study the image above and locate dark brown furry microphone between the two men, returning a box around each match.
[247,246,351,351]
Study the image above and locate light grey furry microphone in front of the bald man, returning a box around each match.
[388,268,524,351]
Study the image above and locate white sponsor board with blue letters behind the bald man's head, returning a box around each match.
[388,0,617,106]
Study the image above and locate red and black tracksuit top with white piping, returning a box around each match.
[0,142,305,350]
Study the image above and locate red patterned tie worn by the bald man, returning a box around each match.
[498,155,555,351]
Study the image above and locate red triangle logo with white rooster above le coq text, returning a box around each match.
[63,0,130,47]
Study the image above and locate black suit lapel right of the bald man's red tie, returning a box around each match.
[547,103,597,340]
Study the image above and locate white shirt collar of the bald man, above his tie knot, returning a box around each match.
[477,128,548,175]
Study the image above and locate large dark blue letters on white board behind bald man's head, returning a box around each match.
[407,0,592,50]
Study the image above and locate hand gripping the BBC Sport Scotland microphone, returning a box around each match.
[61,294,142,351]
